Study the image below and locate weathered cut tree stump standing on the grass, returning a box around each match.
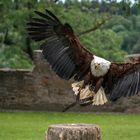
[45,124,101,140]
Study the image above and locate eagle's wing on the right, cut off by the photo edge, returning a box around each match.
[108,61,140,101]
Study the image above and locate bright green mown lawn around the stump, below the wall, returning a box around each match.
[0,112,140,140]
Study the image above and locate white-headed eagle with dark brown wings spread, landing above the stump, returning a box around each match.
[27,9,140,105]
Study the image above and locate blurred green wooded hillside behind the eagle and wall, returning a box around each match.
[0,0,140,68]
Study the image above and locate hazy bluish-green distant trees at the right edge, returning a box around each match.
[104,15,140,53]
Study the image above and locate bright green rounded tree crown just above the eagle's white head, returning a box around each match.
[82,30,126,61]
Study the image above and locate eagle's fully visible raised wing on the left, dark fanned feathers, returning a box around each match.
[27,10,93,80]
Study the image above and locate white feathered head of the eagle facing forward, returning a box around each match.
[91,55,111,77]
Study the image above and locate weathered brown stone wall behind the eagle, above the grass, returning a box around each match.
[0,51,140,113]
